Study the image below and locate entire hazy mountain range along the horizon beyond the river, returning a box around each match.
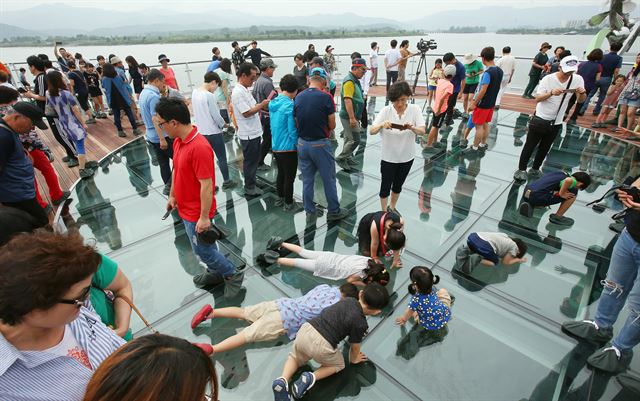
[0,3,601,40]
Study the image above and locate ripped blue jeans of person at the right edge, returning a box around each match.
[595,228,640,351]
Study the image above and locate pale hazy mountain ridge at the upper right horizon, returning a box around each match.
[407,6,604,31]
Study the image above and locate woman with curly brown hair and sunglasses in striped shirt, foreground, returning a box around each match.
[0,231,124,400]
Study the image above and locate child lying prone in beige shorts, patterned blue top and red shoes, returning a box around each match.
[191,283,358,354]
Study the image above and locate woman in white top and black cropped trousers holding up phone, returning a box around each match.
[369,82,426,213]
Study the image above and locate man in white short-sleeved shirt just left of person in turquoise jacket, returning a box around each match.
[231,63,269,196]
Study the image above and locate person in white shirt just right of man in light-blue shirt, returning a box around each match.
[191,71,236,190]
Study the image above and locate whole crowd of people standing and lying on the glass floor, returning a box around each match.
[0,39,640,401]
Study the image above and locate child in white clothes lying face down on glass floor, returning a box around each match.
[272,242,389,286]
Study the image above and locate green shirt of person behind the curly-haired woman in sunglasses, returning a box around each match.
[90,254,133,341]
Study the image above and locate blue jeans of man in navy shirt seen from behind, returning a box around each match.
[298,138,340,213]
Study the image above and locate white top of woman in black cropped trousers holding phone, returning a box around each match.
[373,104,425,163]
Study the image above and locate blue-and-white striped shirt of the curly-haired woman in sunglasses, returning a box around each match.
[0,307,125,401]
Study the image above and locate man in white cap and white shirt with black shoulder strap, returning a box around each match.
[513,56,587,181]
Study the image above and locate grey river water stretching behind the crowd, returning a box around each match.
[0,33,640,90]
